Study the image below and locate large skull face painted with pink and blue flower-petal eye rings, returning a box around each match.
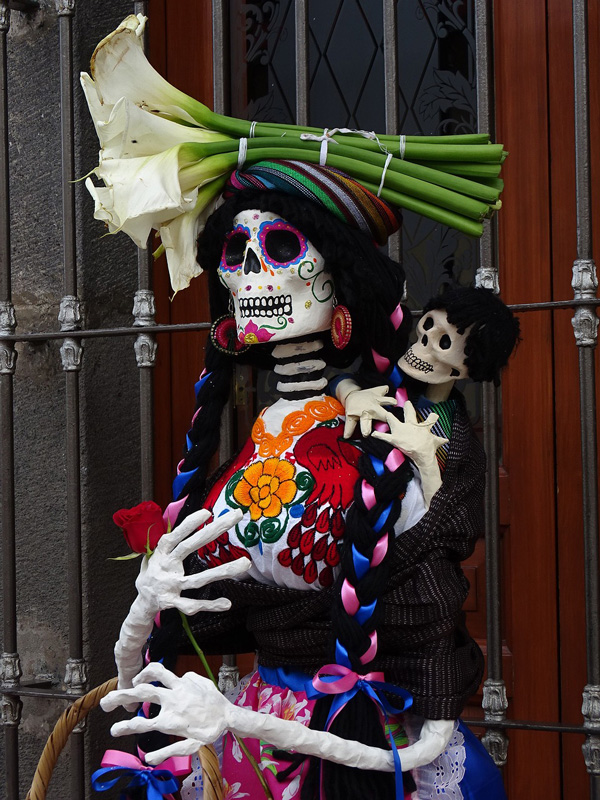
[219,209,333,344]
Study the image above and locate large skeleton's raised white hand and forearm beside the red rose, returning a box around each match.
[115,509,251,689]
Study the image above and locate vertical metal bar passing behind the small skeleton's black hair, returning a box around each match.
[475,0,508,766]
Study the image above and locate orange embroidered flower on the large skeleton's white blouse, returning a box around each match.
[233,458,298,520]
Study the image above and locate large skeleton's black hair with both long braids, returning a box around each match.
[151,190,412,800]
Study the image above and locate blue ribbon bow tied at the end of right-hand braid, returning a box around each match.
[305,675,413,800]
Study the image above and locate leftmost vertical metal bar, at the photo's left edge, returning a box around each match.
[0,2,21,800]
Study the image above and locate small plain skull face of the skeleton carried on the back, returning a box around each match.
[398,308,470,384]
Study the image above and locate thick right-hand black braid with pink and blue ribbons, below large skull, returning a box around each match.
[302,294,412,800]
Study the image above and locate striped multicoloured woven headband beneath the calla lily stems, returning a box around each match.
[223,161,402,244]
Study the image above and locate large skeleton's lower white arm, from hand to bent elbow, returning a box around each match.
[101,663,454,772]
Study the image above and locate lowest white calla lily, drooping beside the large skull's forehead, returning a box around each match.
[159,179,225,292]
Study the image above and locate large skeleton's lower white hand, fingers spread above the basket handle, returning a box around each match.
[100,662,234,764]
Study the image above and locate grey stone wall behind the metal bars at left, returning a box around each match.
[0,0,148,799]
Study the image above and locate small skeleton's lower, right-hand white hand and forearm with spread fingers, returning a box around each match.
[371,400,448,508]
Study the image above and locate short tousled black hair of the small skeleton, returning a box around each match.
[423,287,519,386]
